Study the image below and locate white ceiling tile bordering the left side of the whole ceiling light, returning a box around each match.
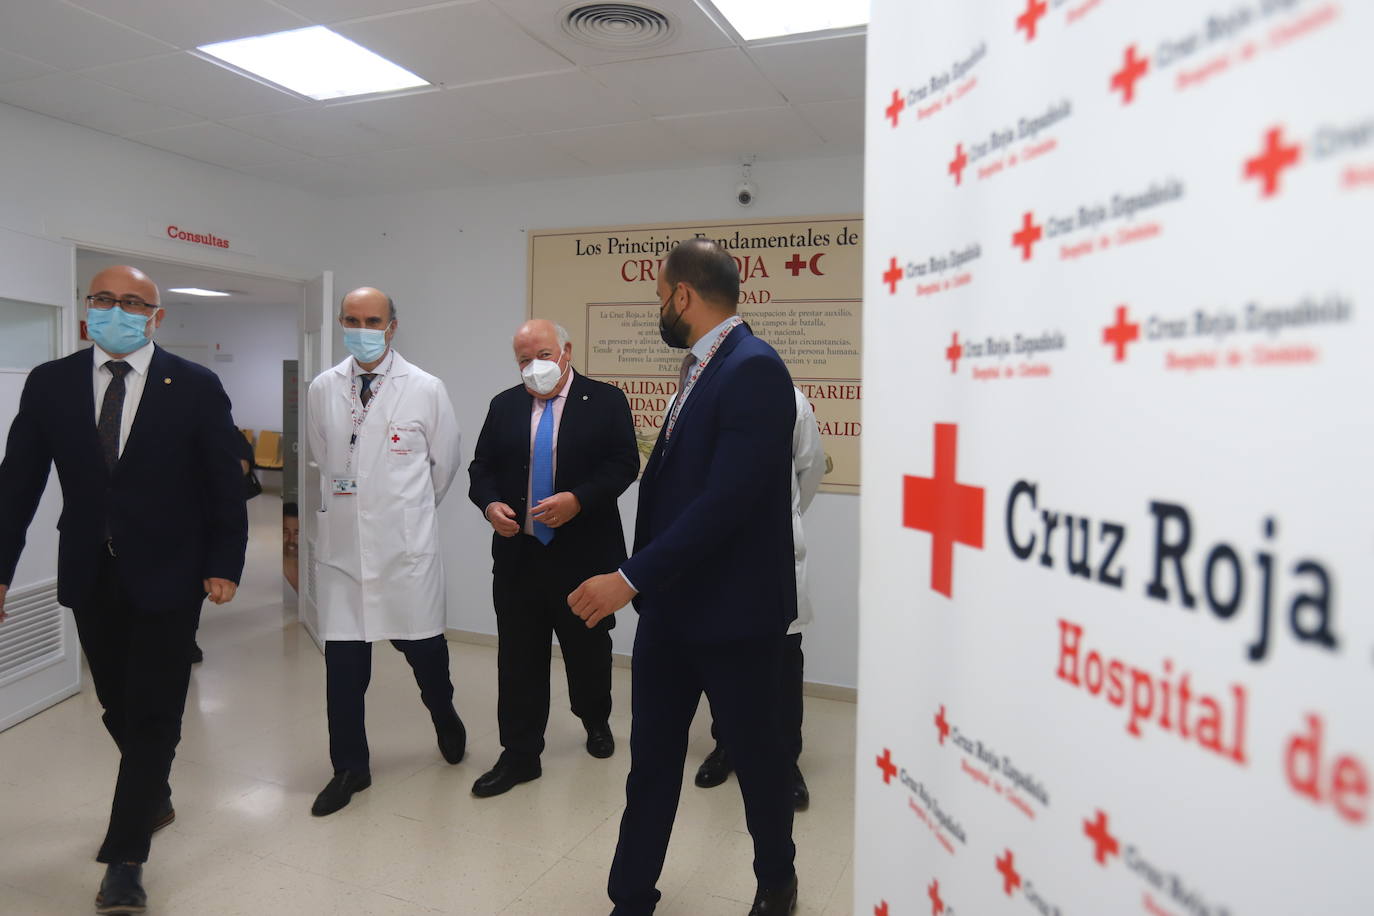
[81,51,304,121]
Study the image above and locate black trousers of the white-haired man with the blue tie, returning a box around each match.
[492,534,610,764]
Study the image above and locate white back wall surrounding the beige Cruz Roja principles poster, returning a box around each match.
[327,158,863,687]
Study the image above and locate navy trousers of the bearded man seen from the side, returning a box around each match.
[609,634,796,916]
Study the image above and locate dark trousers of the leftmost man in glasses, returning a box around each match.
[73,549,196,862]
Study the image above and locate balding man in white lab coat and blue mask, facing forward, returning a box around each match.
[309,287,467,817]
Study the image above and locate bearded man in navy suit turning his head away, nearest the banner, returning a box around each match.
[567,239,797,916]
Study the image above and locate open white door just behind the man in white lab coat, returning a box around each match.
[297,271,334,651]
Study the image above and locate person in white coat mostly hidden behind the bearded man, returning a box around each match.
[695,387,826,810]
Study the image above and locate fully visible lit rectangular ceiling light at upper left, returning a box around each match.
[196,26,430,100]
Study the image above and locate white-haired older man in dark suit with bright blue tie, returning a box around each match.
[469,320,639,798]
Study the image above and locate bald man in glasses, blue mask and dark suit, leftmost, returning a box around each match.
[0,260,247,913]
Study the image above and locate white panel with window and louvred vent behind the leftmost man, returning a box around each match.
[0,229,81,731]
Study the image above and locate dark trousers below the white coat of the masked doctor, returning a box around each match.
[324,633,458,773]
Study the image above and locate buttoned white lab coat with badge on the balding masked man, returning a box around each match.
[309,352,462,643]
